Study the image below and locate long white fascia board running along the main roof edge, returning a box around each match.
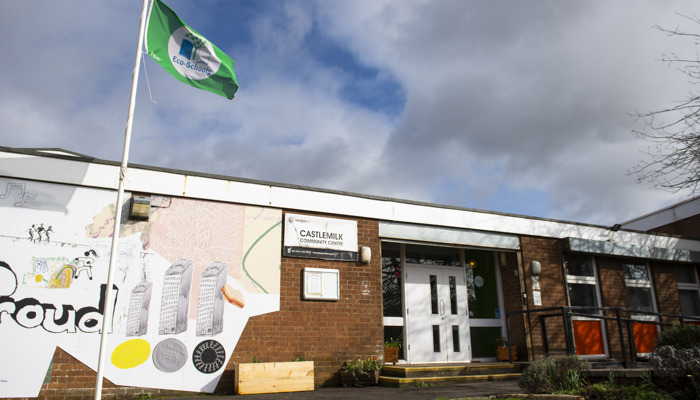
[0,148,700,255]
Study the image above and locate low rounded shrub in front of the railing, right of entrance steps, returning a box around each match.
[518,356,589,393]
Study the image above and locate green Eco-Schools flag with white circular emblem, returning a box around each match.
[146,0,238,99]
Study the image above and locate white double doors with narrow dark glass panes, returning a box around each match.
[405,265,471,364]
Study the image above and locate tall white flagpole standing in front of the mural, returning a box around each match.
[95,0,148,400]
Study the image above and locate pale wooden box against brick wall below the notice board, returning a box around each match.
[236,361,314,394]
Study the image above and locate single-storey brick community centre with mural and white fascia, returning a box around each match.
[0,147,700,398]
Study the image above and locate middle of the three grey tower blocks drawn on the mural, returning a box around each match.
[158,260,192,335]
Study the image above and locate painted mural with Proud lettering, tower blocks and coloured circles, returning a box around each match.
[0,178,282,397]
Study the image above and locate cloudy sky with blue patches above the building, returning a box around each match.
[0,0,700,225]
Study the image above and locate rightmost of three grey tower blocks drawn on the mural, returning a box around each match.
[197,262,228,336]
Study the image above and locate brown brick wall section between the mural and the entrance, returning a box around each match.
[223,214,384,392]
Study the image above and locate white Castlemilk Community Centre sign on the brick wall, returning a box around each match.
[283,214,357,261]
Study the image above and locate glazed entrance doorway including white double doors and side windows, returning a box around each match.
[382,242,515,364]
